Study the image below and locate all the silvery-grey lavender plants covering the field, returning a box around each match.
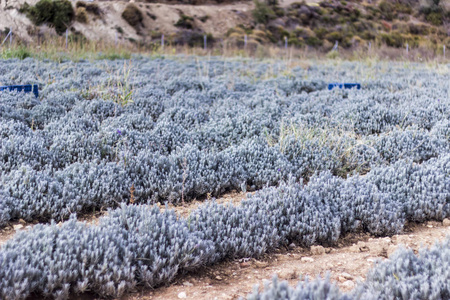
[0,58,450,299]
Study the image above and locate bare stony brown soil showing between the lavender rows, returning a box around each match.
[0,192,450,300]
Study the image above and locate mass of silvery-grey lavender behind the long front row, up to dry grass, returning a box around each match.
[0,58,450,225]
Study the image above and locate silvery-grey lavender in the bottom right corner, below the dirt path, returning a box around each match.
[247,237,450,300]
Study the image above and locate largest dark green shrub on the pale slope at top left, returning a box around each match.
[27,0,75,35]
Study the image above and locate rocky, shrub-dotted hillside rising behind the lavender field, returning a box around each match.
[0,0,450,53]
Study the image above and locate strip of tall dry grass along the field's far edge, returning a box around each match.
[0,34,450,64]
